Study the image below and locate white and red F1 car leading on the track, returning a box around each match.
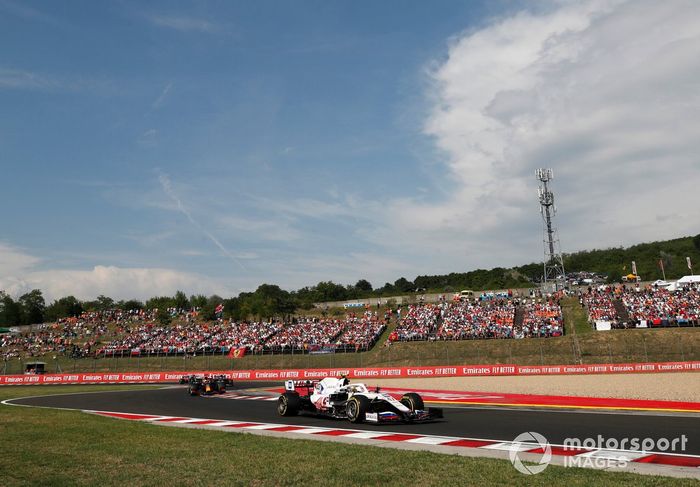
[277,377,443,423]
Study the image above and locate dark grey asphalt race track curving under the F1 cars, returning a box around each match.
[8,383,700,455]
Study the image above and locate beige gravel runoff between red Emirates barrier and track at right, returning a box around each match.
[367,372,700,402]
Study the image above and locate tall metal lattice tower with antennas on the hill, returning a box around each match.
[535,169,566,292]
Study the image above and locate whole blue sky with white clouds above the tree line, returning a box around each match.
[0,0,698,298]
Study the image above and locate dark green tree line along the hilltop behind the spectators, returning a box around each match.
[0,234,700,326]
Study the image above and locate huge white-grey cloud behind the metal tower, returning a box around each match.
[374,0,700,268]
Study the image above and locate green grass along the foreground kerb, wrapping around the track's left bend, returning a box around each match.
[0,386,697,487]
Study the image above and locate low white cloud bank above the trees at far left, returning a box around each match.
[0,244,231,302]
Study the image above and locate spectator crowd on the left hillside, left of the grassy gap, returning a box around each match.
[0,308,386,360]
